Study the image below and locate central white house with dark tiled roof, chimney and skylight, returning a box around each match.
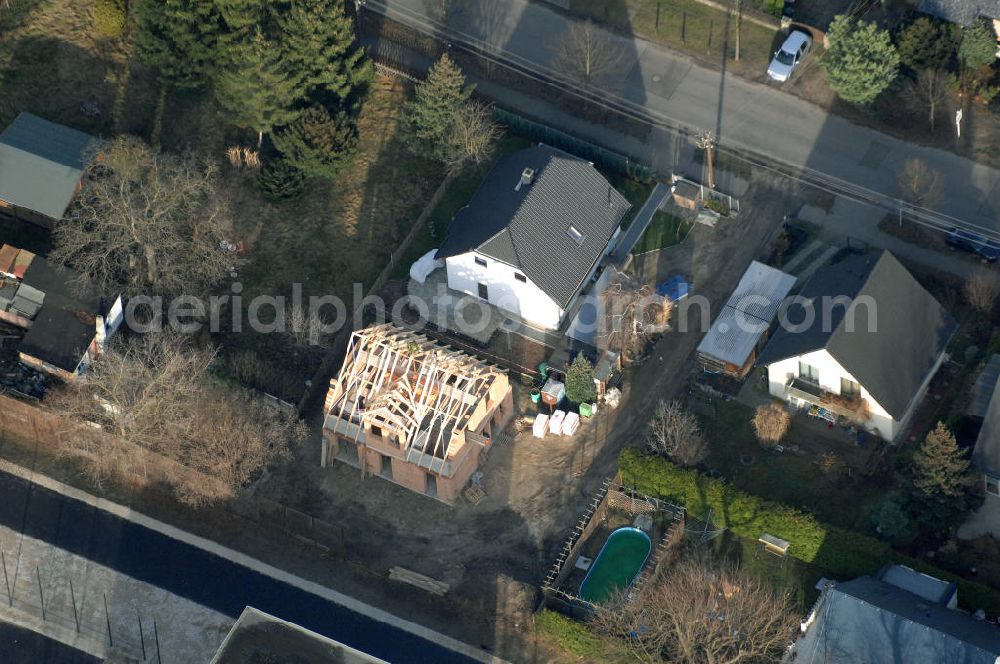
[436,145,631,330]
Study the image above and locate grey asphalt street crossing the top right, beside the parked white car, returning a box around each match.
[372,0,1000,236]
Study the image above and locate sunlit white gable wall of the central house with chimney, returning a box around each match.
[445,251,564,330]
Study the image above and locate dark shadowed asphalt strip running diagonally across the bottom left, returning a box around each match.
[0,472,474,664]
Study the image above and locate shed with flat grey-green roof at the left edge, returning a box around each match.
[0,113,96,229]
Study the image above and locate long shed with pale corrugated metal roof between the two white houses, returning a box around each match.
[698,261,795,367]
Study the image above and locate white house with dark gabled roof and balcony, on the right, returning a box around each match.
[757,251,957,441]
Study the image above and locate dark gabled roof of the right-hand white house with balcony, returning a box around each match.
[758,251,957,419]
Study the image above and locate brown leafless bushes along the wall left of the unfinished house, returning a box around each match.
[52,334,305,505]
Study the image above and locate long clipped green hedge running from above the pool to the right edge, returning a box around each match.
[619,448,1000,615]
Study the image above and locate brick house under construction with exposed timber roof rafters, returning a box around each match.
[321,325,514,503]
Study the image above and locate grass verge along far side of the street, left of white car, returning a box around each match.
[570,0,783,75]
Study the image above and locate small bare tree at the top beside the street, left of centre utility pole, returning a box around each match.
[552,21,625,88]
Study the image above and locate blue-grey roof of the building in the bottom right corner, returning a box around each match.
[793,576,1000,664]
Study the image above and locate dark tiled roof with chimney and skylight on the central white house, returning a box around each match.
[437,145,631,307]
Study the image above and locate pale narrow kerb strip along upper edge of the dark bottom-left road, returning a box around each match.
[0,459,510,664]
